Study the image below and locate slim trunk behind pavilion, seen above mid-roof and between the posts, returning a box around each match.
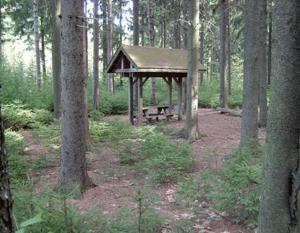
[147,0,156,105]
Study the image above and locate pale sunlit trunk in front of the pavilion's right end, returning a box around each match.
[185,0,200,141]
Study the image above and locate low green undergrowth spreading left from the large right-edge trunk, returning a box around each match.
[177,144,263,228]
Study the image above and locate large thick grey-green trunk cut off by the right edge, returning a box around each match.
[258,0,300,233]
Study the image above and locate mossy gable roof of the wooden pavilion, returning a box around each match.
[107,45,205,73]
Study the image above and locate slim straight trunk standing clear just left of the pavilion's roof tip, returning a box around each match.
[93,0,99,110]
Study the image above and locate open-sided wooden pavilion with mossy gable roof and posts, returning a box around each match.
[107,45,205,124]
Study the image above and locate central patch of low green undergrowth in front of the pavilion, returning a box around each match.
[90,120,193,183]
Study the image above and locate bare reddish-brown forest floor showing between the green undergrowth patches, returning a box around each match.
[21,109,264,233]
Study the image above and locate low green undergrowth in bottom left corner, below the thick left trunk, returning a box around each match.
[13,180,101,233]
